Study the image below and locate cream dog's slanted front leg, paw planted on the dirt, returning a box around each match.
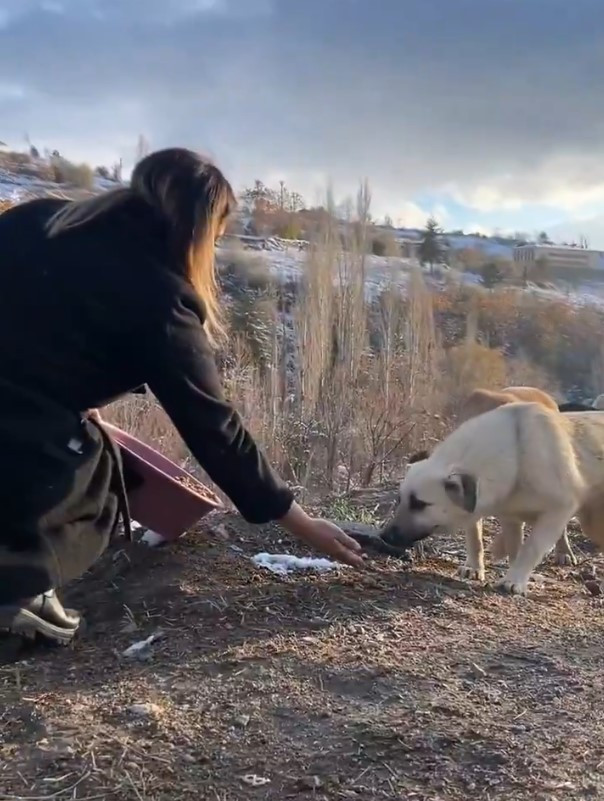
[499,507,575,595]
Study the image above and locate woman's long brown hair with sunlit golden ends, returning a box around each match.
[48,148,236,345]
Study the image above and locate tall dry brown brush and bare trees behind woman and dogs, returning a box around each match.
[106,193,604,497]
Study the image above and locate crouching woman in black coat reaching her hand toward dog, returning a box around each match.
[0,149,362,643]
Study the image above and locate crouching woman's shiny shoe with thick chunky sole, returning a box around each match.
[0,590,81,645]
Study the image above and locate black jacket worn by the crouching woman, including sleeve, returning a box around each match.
[0,199,293,523]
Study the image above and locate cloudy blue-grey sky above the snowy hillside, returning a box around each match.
[0,0,604,242]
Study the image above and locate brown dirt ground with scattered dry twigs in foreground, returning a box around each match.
[0,515,604,801]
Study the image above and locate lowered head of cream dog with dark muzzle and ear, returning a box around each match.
[381,457,477,548]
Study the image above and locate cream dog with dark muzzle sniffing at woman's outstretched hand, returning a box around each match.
[382,403,604,594]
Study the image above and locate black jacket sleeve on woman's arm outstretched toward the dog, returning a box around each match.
[144,288,294,523]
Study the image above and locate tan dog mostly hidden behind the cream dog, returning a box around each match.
[458,387,577,581]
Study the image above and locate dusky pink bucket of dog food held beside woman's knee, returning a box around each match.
[102,421,222,540]
